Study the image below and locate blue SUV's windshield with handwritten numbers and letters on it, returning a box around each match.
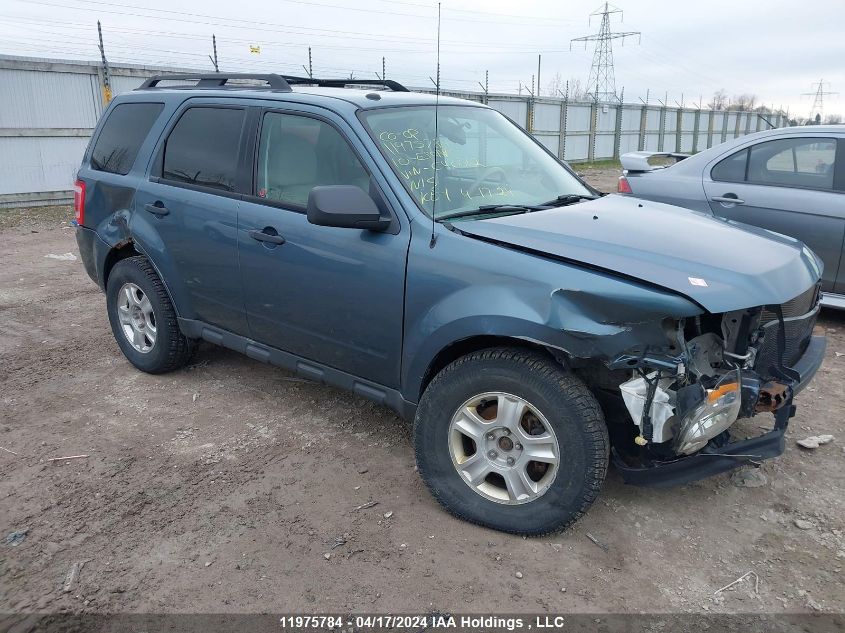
[361,106,591,218]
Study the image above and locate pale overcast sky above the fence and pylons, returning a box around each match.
[0,0,845,116]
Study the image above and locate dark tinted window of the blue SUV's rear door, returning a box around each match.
[161,108,245,191]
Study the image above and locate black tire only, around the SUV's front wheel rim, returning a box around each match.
[414,348,610,536]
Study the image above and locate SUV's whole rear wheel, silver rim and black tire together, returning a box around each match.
[106,256,196,374]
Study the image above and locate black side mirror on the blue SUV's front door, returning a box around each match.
[307,185,390,231]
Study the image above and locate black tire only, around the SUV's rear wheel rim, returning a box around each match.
[106,256,196,374]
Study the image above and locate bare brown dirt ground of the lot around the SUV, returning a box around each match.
[0,168,845,613]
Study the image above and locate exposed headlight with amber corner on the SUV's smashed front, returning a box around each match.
[675,370,742,455]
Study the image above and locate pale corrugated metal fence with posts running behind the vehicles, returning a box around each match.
[0,55,786,207]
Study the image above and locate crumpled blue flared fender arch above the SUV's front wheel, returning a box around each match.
[403,278,703,397]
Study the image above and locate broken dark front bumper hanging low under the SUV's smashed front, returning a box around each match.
[613,336,827,488]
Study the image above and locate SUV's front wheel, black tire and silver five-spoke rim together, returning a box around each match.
[414,348,609,536]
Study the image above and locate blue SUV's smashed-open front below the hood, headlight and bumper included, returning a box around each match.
[592,286,825,486]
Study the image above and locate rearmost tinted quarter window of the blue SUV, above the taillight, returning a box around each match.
[91,103,164,175]
